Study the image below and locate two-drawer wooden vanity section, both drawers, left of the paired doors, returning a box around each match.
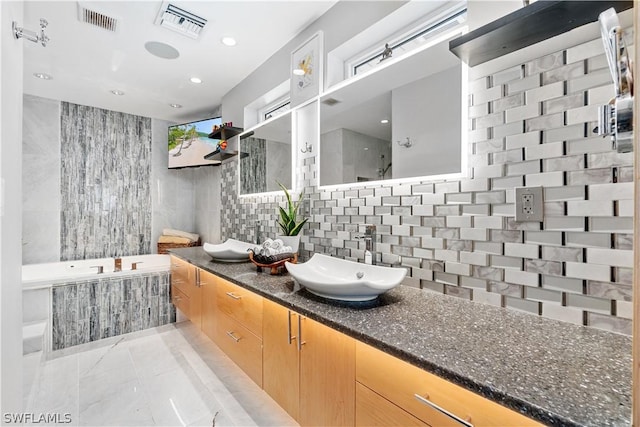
[214,277,262,387]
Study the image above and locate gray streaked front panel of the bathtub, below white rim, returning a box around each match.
[51,272,176,350]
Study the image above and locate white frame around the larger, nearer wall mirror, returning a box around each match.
[316,25,469,190]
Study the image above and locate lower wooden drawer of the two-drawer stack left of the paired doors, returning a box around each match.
[216,314,262,387]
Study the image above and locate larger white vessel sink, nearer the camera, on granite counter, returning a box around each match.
[285,254,407,301]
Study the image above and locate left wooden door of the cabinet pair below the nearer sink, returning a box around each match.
[262,299,300,420]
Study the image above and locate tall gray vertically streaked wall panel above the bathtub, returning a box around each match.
[60,102,151,260]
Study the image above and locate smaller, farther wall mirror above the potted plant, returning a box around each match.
[239,111,292,195]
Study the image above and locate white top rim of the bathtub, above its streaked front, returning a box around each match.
[22,254,171,289]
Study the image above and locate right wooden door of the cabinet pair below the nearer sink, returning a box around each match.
[298,317,355,426]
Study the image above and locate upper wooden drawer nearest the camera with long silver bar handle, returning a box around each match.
[356,342,541,427]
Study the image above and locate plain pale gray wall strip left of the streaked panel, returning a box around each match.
[22,95,60,264]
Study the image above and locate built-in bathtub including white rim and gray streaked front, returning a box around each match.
[22,255,176,352]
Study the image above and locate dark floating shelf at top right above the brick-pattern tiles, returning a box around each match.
[449,0,633,67]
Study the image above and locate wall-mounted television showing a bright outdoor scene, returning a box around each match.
[168,117,222,169]
